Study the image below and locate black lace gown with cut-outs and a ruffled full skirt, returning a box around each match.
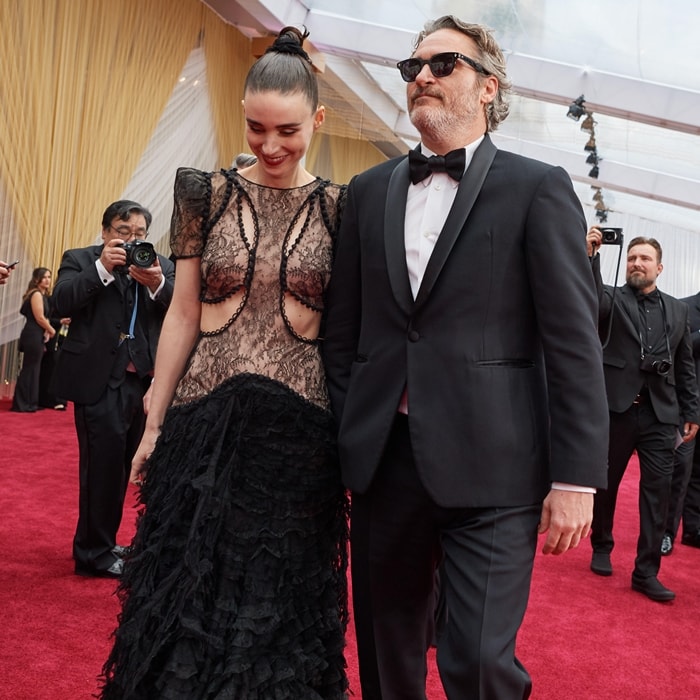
[101,169,347,700]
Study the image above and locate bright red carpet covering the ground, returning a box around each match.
[0,401,700,700]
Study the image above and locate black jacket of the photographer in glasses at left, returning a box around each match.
[52,245,175,404]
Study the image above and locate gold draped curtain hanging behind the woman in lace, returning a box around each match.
[0,0,383,301]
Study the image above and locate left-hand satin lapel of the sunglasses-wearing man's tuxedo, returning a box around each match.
[384,158,413,314]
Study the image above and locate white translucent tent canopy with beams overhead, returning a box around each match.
[205,0,700,238]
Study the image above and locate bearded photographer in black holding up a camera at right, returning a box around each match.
[586,227,699,602]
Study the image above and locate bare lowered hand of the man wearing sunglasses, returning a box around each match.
[537,489,593,554]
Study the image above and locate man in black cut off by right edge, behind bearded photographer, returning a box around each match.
[661,293,700,555]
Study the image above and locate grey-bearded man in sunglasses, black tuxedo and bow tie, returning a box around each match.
[323,16,607,700]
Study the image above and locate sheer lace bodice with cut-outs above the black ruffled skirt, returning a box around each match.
[171,168,342,407]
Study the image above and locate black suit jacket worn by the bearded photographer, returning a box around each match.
[592,255,698,426]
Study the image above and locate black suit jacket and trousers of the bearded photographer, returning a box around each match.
[591,255,698,579]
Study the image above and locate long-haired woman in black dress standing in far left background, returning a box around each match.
[10,267,56,413]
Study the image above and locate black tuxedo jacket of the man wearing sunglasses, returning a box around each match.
[323,136,608,507]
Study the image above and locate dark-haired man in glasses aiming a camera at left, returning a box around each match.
[52,200,175,578]
